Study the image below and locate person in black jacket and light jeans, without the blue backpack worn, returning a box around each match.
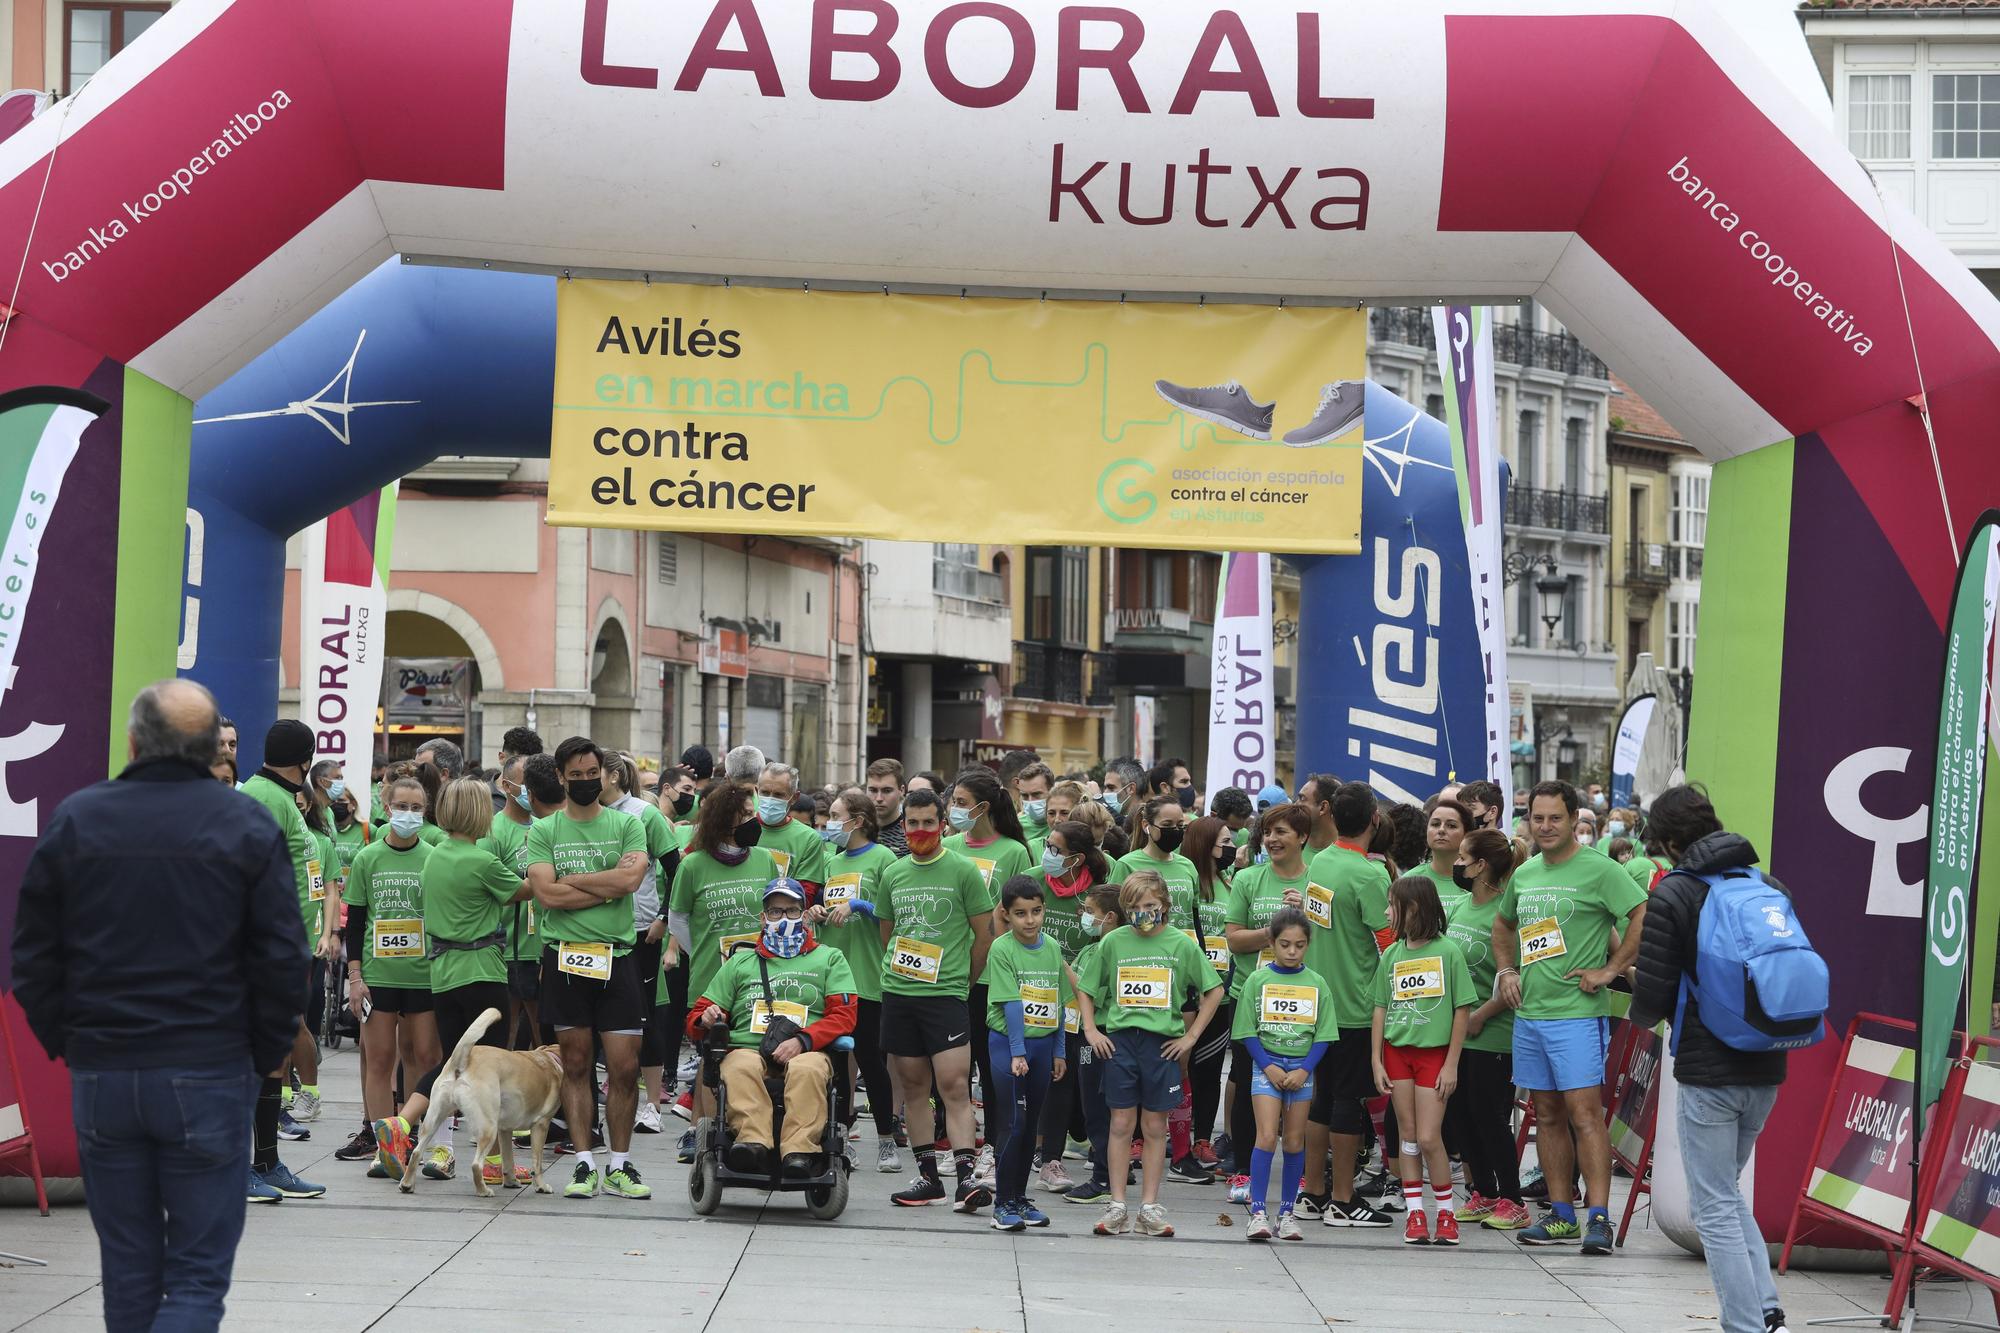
[1632,787,1784,1333]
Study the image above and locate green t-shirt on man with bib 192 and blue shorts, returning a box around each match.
[1498,847,1646,1019]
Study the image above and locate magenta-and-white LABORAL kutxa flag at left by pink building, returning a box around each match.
[298,482,396,819]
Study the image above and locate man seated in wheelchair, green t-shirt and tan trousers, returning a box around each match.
[688,879,856,1179]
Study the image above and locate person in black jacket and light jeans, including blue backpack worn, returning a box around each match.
[1632,787,1828,1333]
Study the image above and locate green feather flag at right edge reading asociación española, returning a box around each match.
[1916,510,2000,1125]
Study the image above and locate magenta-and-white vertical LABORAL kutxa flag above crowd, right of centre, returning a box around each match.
[1202,550,1278,795]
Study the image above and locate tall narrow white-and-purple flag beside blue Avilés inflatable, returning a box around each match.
[1430,306,1514,809]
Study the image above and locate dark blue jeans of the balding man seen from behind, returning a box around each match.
[70,1061,260,1333]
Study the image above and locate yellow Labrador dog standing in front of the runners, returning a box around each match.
[402,1009,562,1199]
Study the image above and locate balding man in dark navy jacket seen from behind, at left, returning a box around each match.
[14,681,308,1329]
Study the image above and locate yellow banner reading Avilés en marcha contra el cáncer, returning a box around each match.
[548,280,1366,554]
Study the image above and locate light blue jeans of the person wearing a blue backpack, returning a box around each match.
[1678,1083,1778,1333]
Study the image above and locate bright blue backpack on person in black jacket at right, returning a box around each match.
[1674,867,1830,1055]
